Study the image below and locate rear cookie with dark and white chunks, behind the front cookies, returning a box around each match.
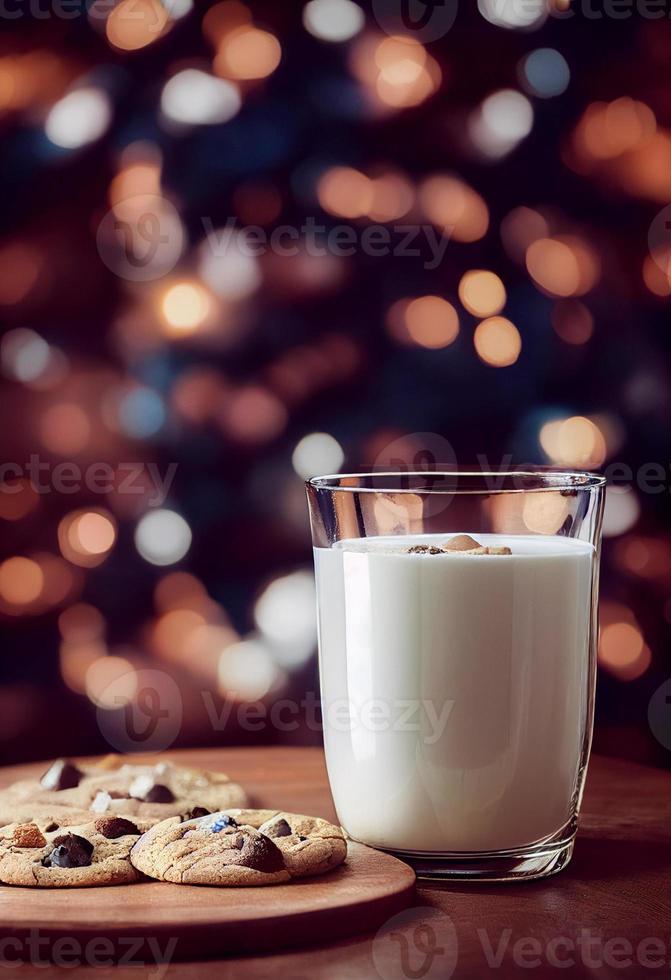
[0,756,247,822]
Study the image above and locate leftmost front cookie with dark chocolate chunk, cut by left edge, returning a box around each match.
[0,810,155,888]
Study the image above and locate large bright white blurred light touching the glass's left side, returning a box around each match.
[254,571,317,667]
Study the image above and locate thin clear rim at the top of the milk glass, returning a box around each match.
[305,466,607,497]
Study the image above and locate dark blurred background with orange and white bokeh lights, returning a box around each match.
[0,0,671,765]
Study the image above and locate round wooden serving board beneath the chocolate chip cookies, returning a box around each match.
[0,748,415,963]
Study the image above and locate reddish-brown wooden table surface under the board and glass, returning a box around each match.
[0,748,671,980]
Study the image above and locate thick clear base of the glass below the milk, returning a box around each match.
[391,835,575,882]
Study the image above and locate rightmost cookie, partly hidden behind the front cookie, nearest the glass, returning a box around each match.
[226,810,347,878]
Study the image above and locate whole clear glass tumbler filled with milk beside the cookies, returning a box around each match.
[306,469,605,881]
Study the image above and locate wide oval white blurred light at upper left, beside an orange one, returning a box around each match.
[161,68,242,126]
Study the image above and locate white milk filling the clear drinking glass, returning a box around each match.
[315,534,594,851]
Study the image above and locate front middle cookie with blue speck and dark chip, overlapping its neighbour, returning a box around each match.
[130,813,289,886]
